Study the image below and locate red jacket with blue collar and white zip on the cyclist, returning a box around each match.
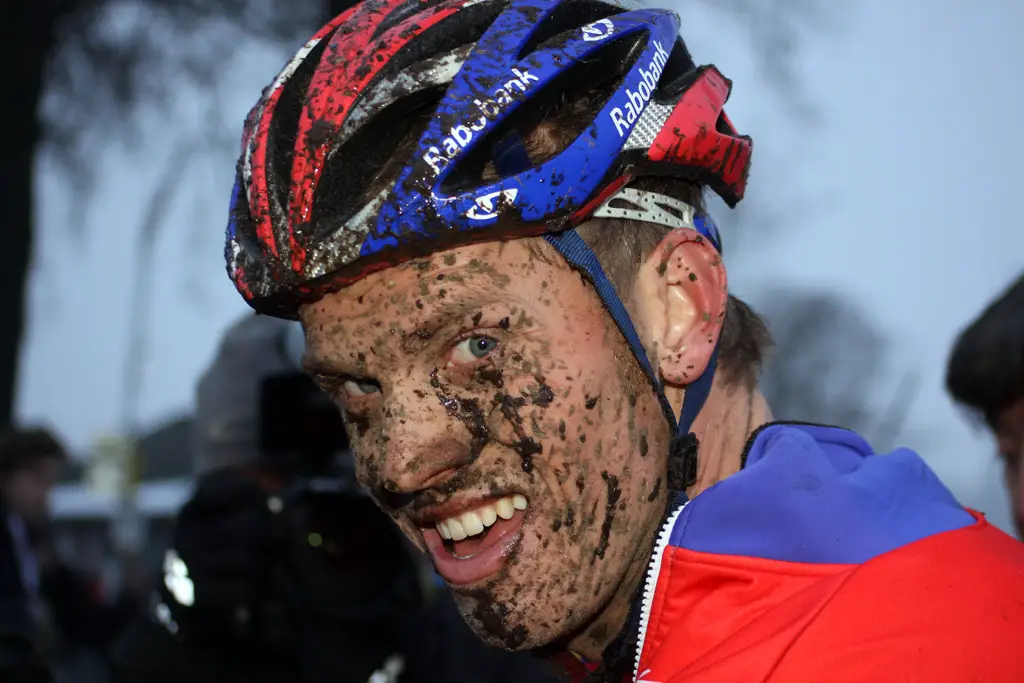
[581,424,1024,683]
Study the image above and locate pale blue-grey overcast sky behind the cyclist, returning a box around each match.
[18,0,1024,528]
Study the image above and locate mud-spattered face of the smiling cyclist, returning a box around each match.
[302,240,669,648]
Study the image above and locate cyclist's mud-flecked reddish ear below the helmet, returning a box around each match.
[635,228,729,386]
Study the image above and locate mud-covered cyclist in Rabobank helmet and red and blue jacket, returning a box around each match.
[220,0,1024,682]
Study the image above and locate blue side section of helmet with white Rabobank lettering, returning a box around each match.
[361,0,679,256]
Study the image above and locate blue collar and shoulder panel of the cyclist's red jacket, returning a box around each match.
[670,423,975,564]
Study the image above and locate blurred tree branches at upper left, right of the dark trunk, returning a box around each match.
[40,0,324,187]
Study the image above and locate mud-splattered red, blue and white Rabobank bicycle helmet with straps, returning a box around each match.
[225,0,752,448]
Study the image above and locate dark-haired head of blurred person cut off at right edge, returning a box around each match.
[946,273,1024,539]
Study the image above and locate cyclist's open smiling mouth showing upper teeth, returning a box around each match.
[422,494,528,585]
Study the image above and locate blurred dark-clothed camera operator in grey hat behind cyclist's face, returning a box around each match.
[116,317,556,683]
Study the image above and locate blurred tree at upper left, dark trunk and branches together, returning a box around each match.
[0,0,336,424]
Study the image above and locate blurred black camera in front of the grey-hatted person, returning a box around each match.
[253,373,420,621]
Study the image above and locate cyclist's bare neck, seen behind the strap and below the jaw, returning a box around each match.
[568,378,772,661]
